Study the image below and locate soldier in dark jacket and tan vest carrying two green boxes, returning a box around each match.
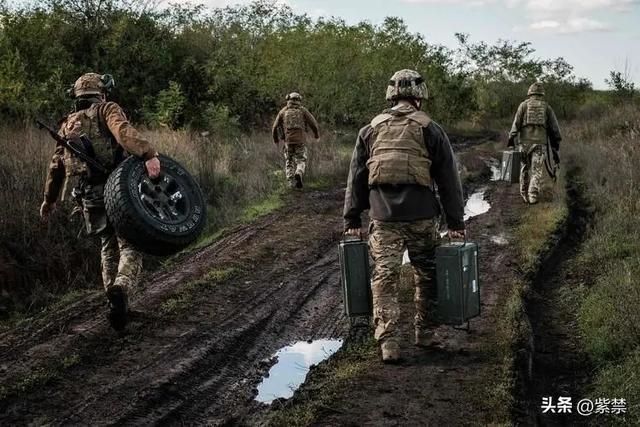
[344,70,465,363]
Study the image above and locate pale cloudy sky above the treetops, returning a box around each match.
[190,0,640,89]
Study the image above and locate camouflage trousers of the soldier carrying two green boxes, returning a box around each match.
[369,219,437,341]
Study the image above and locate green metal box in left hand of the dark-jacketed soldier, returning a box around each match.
[339,237,373,317]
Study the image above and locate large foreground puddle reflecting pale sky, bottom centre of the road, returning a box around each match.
[256,340,342,404]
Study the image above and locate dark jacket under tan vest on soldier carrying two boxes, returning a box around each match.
[344,107,464,230]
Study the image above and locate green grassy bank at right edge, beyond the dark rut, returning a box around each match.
[567,105,640,425]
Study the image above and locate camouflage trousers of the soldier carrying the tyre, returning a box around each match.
[82,184,142,292]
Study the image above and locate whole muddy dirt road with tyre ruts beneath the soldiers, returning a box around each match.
[0,135,584,425]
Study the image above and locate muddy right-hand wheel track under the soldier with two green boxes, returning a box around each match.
[282,182,525,426]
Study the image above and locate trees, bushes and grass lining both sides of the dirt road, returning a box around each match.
[0,0,640,423]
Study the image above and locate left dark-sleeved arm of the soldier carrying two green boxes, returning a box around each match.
[343,126,372,230]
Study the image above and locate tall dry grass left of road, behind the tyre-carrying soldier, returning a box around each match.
[0,123,350,320]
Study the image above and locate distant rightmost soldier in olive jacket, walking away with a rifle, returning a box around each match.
[508,82,562,205]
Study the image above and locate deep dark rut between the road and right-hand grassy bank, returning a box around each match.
[517,173,593,426]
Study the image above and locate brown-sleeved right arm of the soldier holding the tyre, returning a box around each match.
[102,102,158,160]
